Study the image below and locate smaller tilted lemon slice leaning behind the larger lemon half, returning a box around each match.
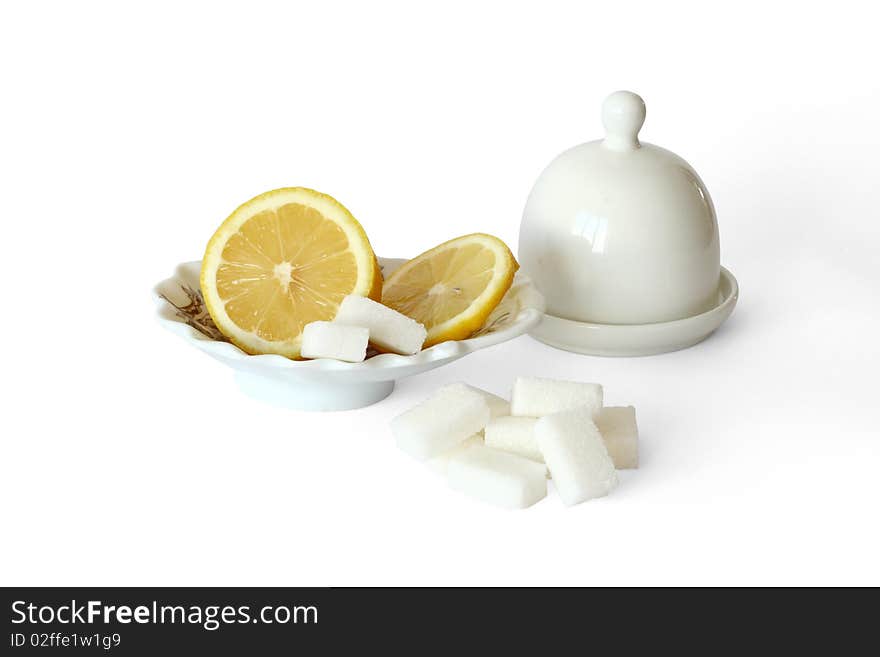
[382,233,519,348]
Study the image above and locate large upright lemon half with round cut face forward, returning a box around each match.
[200,187,382,358]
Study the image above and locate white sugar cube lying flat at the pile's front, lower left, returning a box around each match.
[446,445,547,509]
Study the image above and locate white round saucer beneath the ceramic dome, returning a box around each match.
[529,267,739,356]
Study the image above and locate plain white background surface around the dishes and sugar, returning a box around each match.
[0,0,880,585]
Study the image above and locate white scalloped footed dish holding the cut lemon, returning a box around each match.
[153,258,544,411]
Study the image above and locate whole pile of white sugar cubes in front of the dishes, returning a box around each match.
[391,377,638,509]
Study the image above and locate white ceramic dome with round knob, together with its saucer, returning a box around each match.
[519,91,738,356]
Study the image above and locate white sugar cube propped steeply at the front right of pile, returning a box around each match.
[535,406,617,506]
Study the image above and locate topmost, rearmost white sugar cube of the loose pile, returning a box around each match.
[510,376,602,417]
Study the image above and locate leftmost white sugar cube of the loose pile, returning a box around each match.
[391,386,489,461]
